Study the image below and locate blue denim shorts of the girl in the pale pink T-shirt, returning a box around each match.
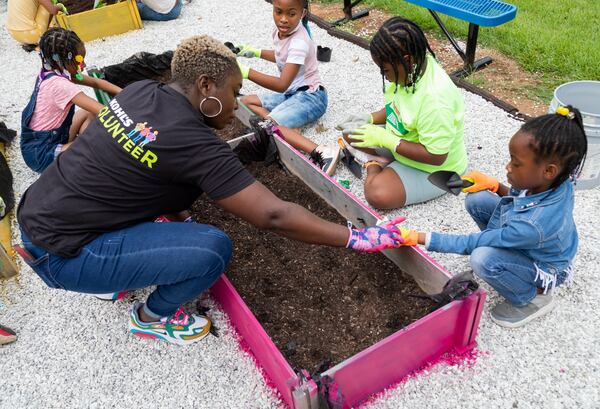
[259,88,327,128]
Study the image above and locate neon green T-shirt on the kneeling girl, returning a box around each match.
[385,55,468,174]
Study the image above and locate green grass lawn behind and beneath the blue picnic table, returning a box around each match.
[320,0,600,92]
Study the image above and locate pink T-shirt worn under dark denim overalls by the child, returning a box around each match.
[29,75,82,131]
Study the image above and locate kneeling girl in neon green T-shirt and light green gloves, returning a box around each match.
[338,17,467,209]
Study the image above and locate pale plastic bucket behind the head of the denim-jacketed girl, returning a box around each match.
[548,81,600,189]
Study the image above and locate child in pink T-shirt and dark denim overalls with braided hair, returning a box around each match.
[21,28,121,173]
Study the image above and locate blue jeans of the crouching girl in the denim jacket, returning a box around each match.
[465,190,566,306]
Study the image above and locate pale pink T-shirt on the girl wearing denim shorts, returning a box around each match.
[273,23,321,92]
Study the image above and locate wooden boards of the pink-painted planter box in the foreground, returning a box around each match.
[211,107,486,409]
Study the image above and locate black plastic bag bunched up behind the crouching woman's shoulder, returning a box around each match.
[101,51,173,88]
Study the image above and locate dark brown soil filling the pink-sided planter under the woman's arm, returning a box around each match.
[193,164,434,371]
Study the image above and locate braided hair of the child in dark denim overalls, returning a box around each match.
[40,27,83,72]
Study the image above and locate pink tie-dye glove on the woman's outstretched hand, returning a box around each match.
[346,217,405,253]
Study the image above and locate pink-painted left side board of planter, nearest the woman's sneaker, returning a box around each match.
[211,275,299,408]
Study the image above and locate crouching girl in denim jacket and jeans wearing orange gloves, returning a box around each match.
[402,106,587,328]
